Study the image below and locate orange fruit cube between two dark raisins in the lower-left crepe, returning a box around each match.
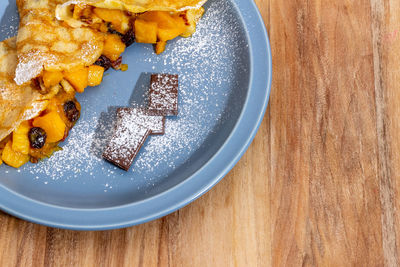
[32,111,66,143]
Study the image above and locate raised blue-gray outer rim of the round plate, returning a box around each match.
[0,0,272,230]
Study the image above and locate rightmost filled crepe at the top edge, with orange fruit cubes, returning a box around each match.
[56,0,206,54]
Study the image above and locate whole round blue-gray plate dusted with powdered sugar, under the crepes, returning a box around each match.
[0,0,272,230]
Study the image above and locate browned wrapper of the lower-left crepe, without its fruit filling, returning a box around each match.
[0,37,57,141]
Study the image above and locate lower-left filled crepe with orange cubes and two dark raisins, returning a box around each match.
[0,38,80,168]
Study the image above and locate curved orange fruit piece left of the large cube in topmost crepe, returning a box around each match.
[93,7,129,34]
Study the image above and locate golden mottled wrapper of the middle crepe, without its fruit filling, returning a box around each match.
[15,0,104,85]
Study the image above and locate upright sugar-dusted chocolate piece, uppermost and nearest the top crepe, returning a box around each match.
[148,74,178,116]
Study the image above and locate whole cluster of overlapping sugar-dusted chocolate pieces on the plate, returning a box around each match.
[103,74,178,171]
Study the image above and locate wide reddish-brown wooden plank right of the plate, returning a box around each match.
[270,0,386,266]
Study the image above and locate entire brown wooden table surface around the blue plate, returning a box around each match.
[0,0,400,267]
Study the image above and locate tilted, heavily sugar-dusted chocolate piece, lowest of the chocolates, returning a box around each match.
[103,113,151,171]
